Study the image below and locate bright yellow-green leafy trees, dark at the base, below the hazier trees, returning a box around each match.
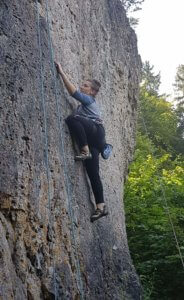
[124,140,184,300]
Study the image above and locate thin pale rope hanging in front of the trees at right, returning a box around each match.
[140,109,184,269]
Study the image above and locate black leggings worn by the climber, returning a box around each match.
[66,115,105,204]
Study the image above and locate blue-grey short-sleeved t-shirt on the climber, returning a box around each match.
[72,91,102,123]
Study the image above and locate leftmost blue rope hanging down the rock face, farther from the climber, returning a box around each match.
[36,0,57,300]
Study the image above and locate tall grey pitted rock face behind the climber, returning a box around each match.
[0,0,140,300]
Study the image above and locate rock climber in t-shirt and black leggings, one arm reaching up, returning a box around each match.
[55,62,108,222]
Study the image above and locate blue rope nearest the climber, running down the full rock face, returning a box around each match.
[46,0,84,299]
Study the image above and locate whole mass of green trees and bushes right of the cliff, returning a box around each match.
[124,62,184,300]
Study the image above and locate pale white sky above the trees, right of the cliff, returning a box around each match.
[132,0,184,97]
